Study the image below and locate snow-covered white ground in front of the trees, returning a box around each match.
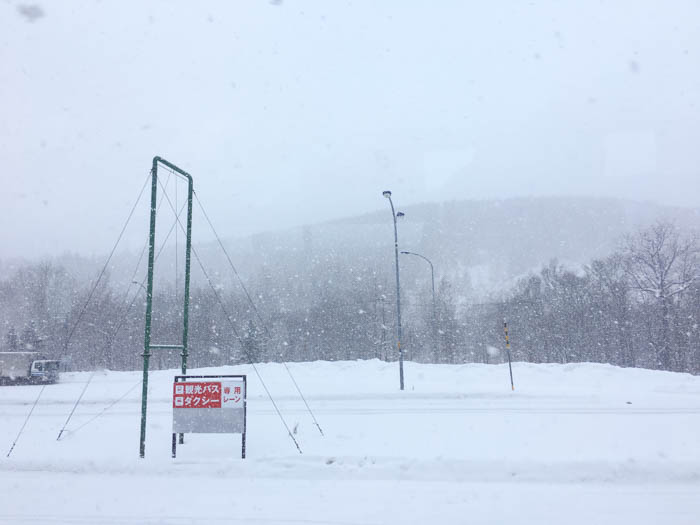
[0,361,700,525]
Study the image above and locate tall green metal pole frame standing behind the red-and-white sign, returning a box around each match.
[139,156,194,458]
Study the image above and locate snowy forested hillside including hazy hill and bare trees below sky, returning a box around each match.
[0,198,700,373]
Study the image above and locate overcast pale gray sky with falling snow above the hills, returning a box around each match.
[0,0,700,257]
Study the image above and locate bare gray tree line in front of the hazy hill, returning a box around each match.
[0,222,700,374]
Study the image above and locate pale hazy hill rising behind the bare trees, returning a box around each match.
[187,197,700,302]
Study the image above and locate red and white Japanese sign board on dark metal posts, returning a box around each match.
[172,375,248,459]
